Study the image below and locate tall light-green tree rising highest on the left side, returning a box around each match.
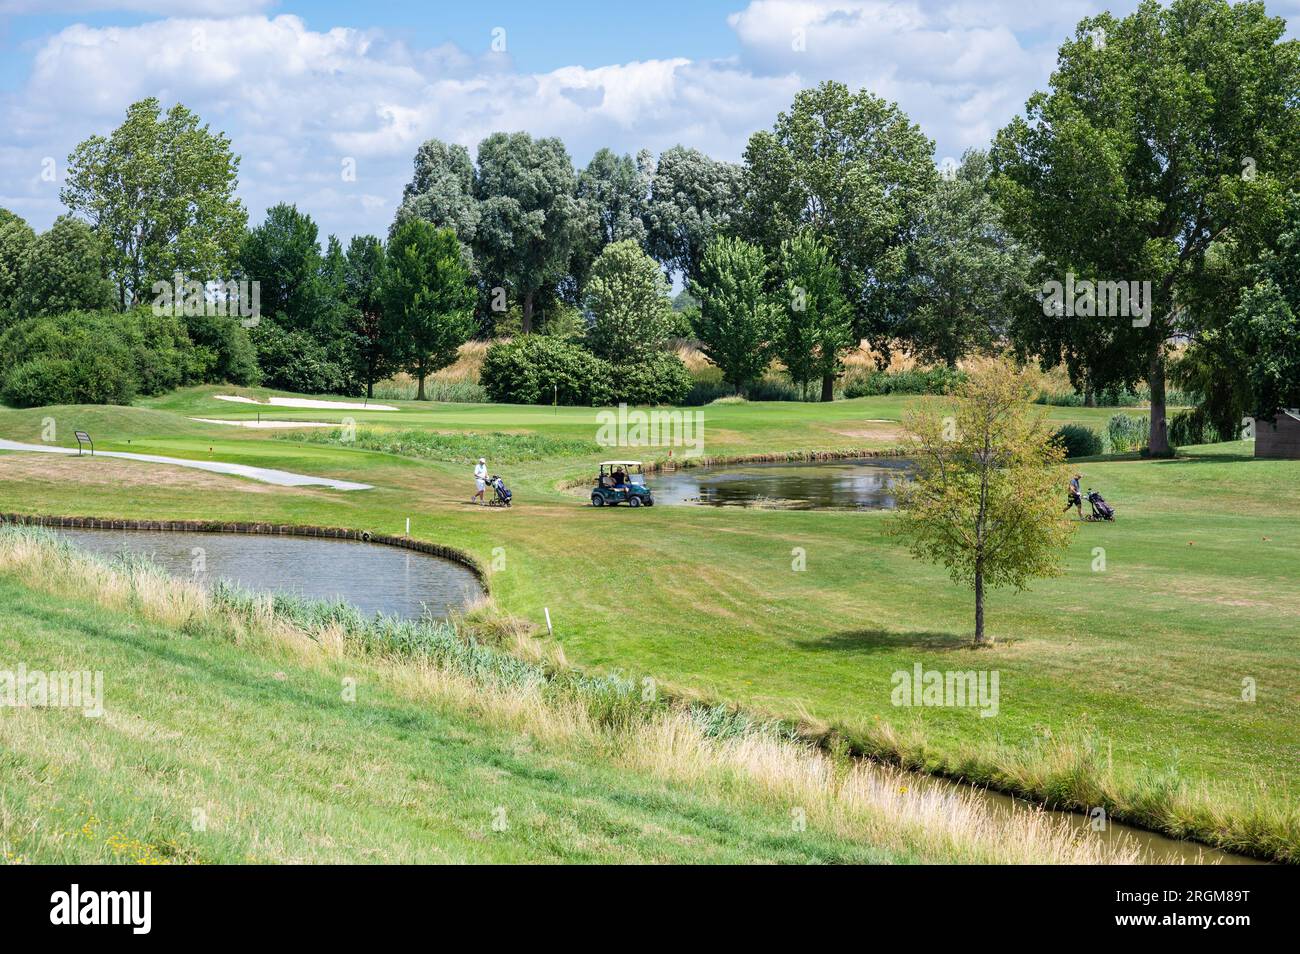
[60,97,248,308]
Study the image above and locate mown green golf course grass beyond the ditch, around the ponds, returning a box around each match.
[0,387,1300,858]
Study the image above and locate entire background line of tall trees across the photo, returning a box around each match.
[0,0,1300,454]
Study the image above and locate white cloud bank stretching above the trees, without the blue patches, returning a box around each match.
[0,0,1279,243]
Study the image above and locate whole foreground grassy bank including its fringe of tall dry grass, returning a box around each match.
[0,528,1138,864]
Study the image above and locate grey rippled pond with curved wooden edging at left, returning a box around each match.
[59,529,482,619]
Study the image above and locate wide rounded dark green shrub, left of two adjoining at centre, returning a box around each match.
[478,334,613,407]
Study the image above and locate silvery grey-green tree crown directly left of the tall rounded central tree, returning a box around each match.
[642,146,741,279]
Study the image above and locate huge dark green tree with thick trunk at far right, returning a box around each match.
[993,0,1300,455]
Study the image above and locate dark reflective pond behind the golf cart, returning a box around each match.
[649,458,910,509]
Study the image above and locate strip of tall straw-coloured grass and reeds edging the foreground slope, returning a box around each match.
[0,526,1159,864]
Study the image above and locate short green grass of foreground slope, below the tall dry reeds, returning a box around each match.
[0,571,907,863]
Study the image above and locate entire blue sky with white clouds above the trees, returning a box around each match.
[0,0,1300,239]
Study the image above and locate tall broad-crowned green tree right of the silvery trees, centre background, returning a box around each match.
[741,82,937,400]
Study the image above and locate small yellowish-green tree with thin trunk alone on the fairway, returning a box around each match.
[894,360,1076,646]
